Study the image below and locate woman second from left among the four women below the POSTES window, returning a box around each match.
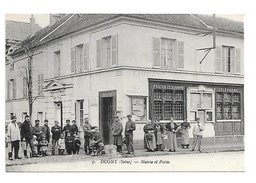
[154,120,164,151]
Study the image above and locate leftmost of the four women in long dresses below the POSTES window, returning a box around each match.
[143,120,156,152]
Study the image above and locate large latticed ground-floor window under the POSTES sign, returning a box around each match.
[152,89,184,120]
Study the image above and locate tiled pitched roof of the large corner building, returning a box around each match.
[11,14,243,54]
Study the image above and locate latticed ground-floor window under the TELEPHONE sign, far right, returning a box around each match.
[216,92,241,120]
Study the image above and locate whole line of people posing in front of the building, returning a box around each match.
[7,115,203,160]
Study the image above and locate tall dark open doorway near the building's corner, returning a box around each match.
[100,91,116,144]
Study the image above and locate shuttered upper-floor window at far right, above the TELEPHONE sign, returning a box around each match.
[215,46,241,73]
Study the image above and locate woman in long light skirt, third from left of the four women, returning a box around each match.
[166,116,178,152]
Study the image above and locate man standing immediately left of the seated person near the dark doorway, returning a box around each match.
[82,118,92,155]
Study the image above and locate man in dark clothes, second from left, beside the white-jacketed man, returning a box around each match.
[21,115,39,158]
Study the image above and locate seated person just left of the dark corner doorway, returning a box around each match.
[90,127,104,156]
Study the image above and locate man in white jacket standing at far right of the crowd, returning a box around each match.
[192,118,204,153]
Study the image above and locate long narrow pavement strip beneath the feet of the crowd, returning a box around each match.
[6,144,244,166]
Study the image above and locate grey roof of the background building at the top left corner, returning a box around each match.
[5,20,41,41]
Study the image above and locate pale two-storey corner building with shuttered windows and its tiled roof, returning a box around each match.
[6,14,244,148]
